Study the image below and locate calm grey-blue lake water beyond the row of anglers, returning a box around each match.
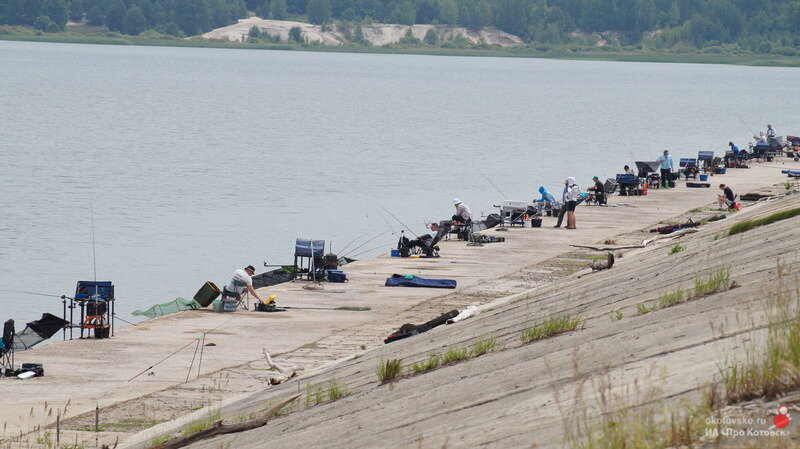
[0,42,800,322]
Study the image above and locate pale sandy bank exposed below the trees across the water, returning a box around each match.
[203,17,523,47]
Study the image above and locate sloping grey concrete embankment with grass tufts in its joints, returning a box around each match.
[162,188,800,449]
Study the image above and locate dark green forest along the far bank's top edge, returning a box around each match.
[0,0,800,52]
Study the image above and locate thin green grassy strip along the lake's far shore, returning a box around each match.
[0,34,800,67]
